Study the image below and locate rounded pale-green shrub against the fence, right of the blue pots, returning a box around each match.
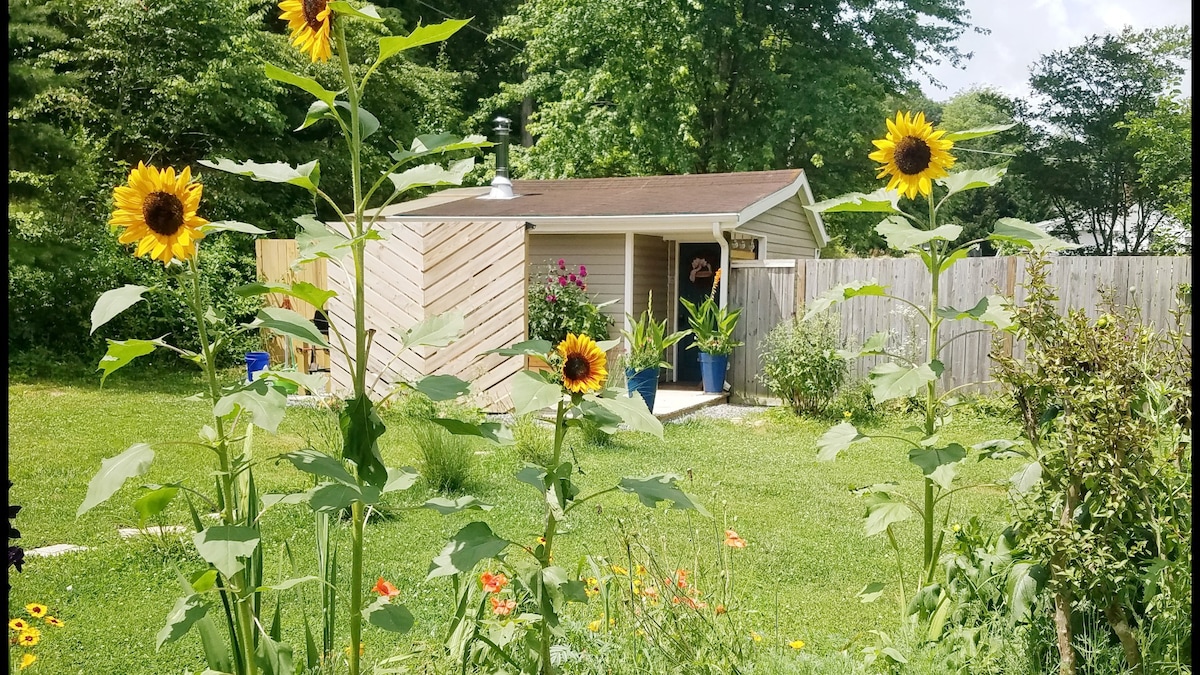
[758,307,850,416]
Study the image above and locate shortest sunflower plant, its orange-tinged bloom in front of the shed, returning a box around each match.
[427,335,707,675]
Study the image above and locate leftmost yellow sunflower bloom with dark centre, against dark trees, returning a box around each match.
[108,162,209,264]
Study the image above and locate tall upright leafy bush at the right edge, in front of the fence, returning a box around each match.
[992,252,1192,675]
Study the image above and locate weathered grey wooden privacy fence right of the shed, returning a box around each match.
[728,256,1192,401]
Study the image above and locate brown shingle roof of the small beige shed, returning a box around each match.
[403,169,802,219]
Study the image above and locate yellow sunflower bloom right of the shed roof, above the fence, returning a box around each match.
[868,113,954,199]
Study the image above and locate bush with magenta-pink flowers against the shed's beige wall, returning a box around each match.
[528,258,617,345]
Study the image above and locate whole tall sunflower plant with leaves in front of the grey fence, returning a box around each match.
[804,113,1073,629]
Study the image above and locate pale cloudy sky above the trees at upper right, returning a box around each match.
[922,0,1192,101]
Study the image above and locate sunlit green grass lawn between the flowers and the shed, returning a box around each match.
[8,369,1019,675]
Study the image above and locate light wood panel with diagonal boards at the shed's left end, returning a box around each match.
[329,221,526,411]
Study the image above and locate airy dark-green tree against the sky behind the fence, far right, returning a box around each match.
[1013,26,1192,255]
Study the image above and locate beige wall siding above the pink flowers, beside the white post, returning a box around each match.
[528,229,625,338]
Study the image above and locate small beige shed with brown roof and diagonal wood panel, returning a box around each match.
[330,169,828,410]
